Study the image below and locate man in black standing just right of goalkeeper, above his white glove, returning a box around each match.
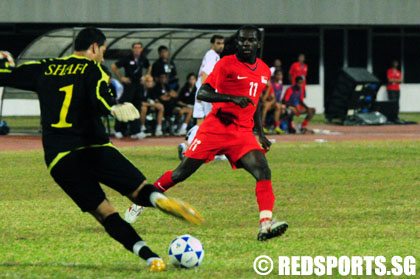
[111,42,151,139]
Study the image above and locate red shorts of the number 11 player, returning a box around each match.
[185,123,266,169]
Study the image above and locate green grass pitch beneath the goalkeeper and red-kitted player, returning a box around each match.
[0,141,420,279]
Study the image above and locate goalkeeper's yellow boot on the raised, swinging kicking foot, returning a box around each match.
[152,193,203,225]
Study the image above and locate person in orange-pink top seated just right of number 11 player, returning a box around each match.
[262,70,286,134]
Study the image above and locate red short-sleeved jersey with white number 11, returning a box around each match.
[200,55,271,133]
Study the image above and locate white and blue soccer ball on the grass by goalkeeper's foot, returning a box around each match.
[169,234,204,268]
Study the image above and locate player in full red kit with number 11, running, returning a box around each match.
[155,26,288,240]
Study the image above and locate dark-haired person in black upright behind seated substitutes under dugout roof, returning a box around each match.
[152,46,179,90]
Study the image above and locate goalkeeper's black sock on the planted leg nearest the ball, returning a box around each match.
[103,213,159,260]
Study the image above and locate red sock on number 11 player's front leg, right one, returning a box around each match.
[255,180,275,222]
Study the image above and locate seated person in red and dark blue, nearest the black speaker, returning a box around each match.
[283,76,315,134]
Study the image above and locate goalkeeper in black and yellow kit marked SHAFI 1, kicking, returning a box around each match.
[0,28,201,271]
